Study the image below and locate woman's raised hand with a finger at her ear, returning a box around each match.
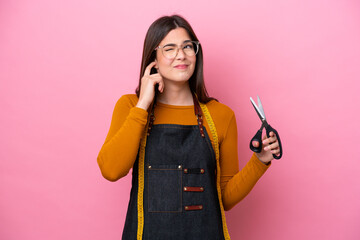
[136,62,164,110]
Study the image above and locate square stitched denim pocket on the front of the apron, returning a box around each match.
[148,165,182,212]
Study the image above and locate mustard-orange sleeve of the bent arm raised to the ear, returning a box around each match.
[97,95,148,181]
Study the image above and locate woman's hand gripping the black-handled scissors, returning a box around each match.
[252,132,280,164]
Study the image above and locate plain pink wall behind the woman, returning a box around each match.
[0,0,360,240]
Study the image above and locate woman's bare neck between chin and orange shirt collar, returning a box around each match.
[157,81,194,106]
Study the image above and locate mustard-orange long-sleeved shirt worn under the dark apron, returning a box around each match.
[97,94,270,210]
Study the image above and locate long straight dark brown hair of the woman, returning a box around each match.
[135,15,216,103]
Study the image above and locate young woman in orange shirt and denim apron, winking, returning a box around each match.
[97,15,279,240]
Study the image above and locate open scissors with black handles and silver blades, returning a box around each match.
[250,96,282,159]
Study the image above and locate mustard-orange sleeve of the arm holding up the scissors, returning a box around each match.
[220,114,270,210]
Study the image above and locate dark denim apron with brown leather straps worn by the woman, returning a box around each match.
[122,98,224,240]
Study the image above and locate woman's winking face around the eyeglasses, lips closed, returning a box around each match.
[155,28,196,82]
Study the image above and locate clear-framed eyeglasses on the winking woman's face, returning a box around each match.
[155,41,200,59]
